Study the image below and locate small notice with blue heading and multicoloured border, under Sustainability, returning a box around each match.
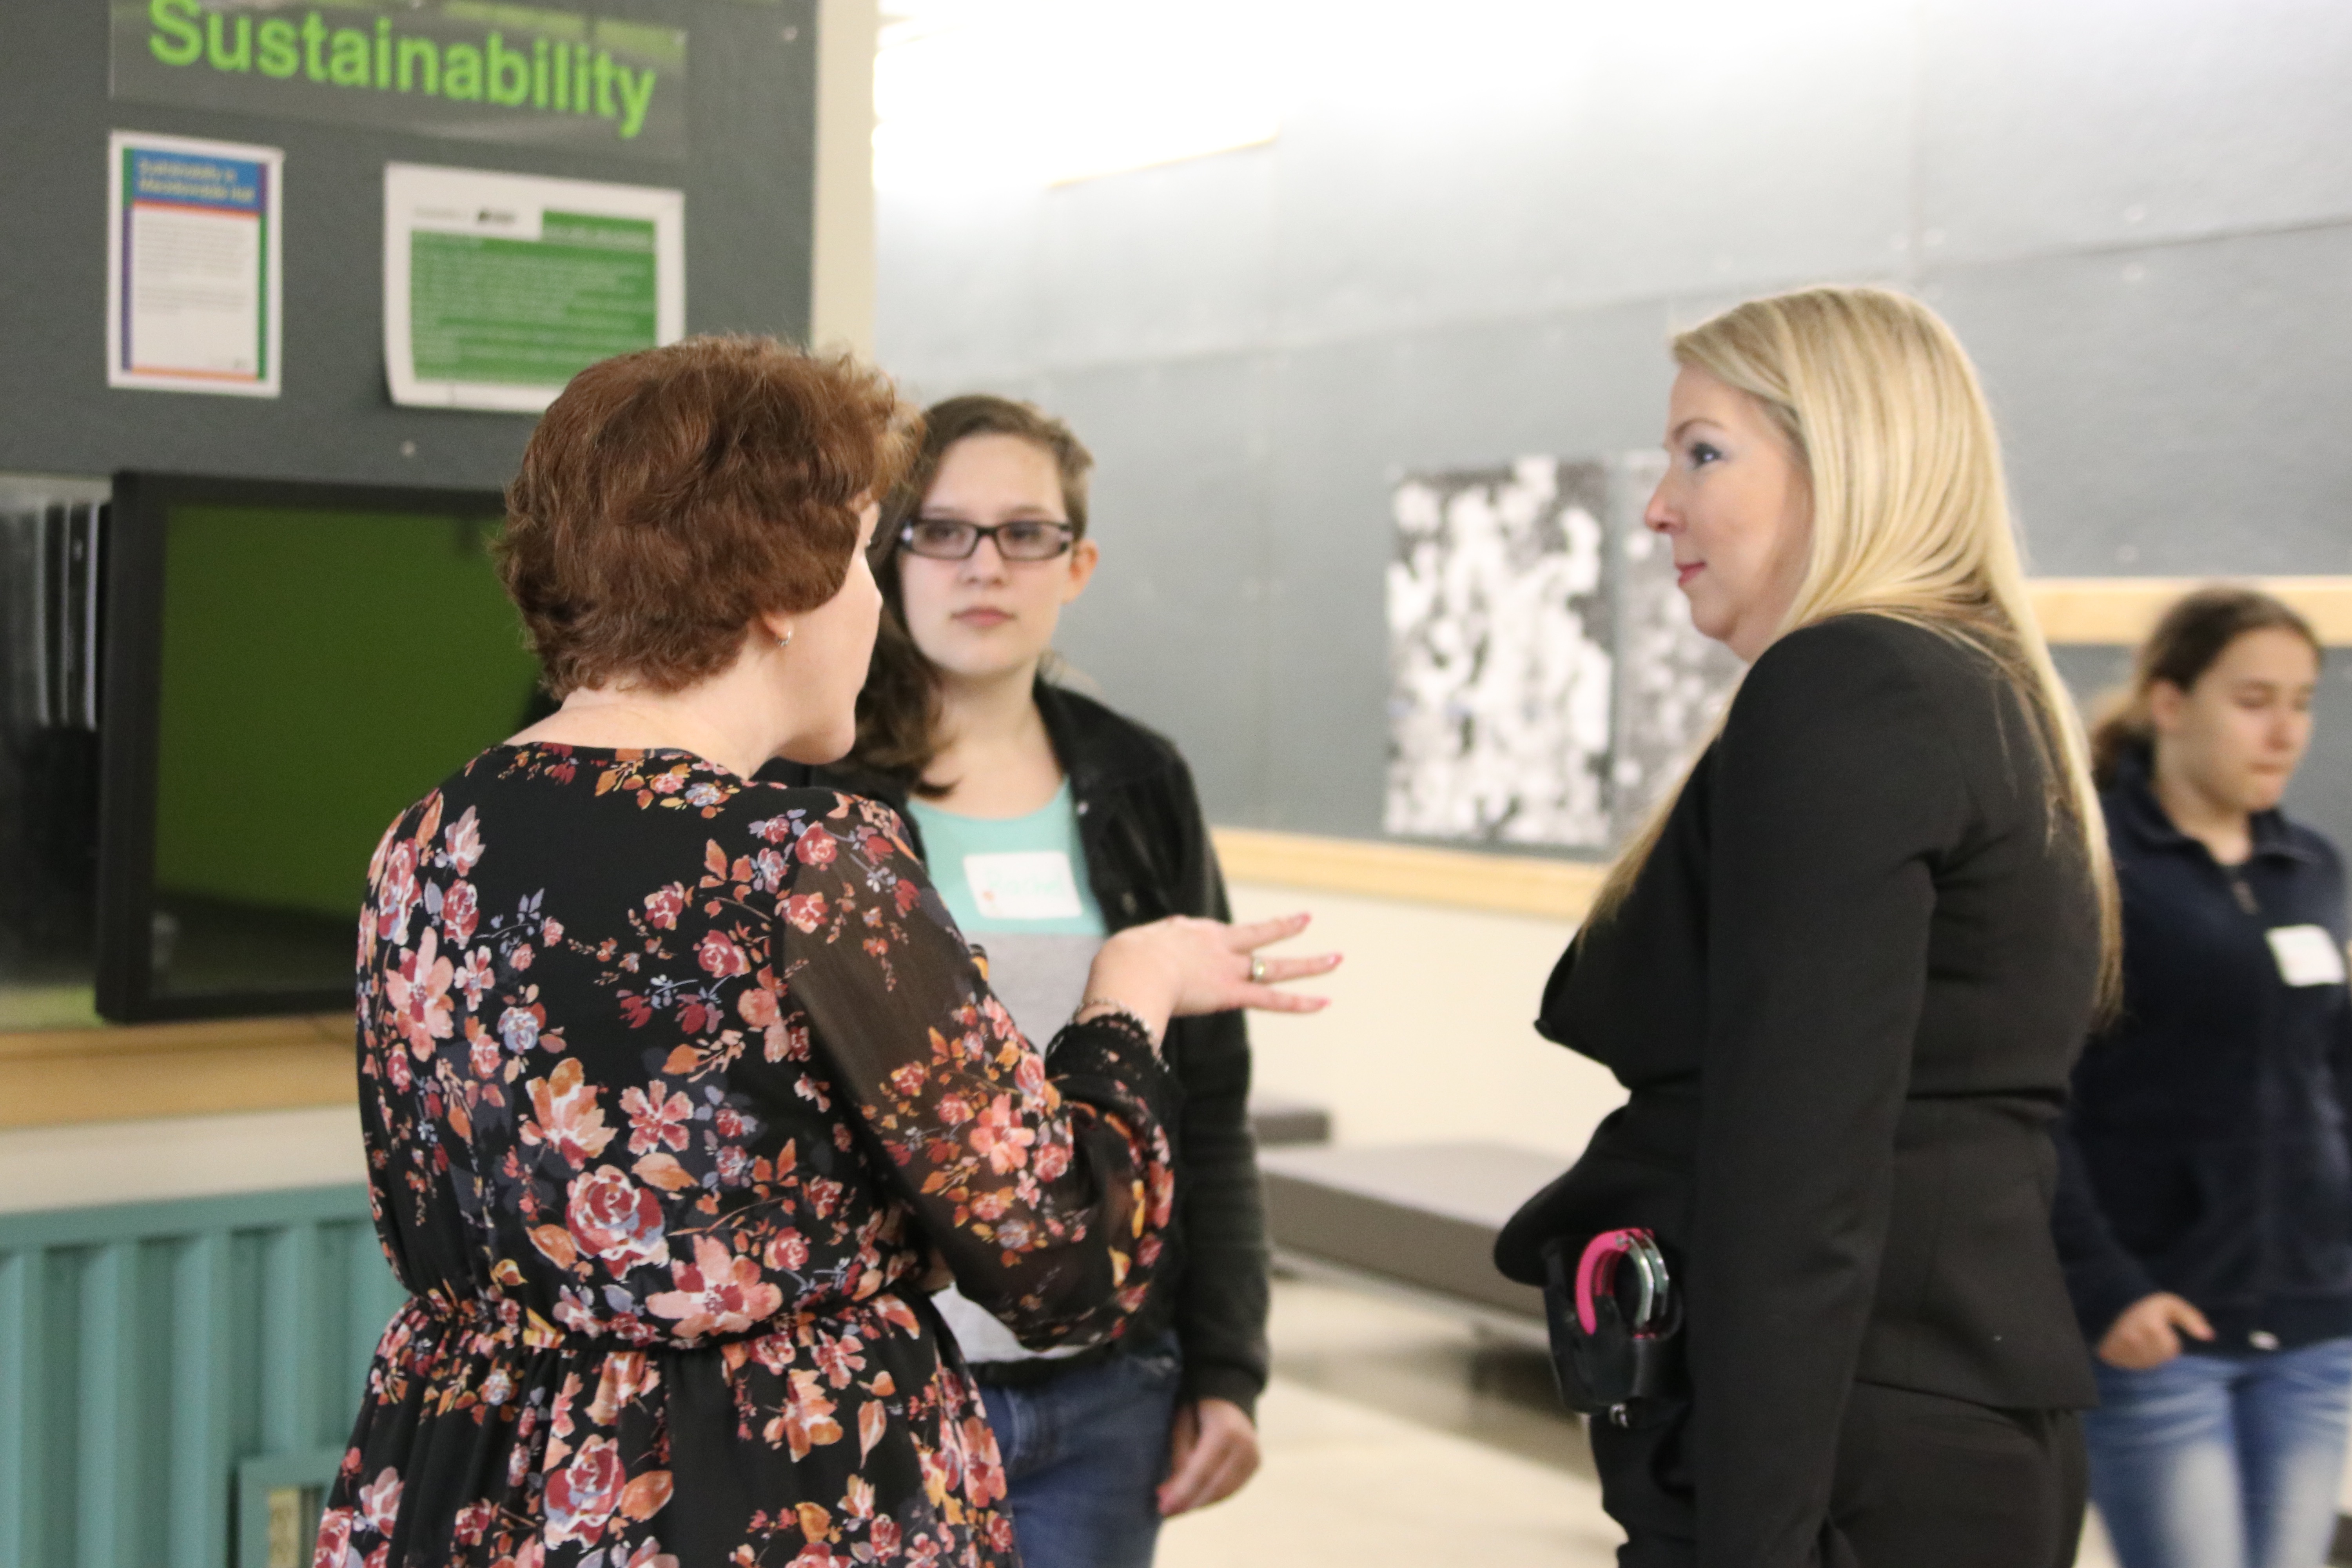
[106,132,285,397]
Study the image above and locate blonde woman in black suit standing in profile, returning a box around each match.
[1498,289,2114,1568]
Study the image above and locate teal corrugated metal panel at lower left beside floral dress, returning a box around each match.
[0,1187,405,1568]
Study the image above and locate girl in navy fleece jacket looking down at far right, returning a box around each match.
[2056,588,2352,1568]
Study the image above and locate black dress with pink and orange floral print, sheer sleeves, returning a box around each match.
[315,745,1171,1568]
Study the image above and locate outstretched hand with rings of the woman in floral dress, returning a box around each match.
[1080,915,1338,1037]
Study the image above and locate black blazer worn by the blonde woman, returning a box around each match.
[1496,616,2098,1568]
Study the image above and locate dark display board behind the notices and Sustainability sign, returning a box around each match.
[0,0,816,486]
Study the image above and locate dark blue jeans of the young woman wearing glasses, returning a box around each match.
[981,1335,1183,1568]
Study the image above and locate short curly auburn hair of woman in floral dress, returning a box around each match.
[499,336,917,698]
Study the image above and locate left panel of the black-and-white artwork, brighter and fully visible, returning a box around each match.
[1383,458,1613,849]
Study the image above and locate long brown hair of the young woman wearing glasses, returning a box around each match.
[849,392,1094,795]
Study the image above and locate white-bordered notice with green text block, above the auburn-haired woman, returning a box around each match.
[383,162,687,414]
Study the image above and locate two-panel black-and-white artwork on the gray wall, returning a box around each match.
[1383,451,1740,853]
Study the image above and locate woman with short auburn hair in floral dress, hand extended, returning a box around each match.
[318,339,1331,1568]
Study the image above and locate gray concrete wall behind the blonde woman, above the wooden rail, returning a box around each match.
[877,0,2352,837]
